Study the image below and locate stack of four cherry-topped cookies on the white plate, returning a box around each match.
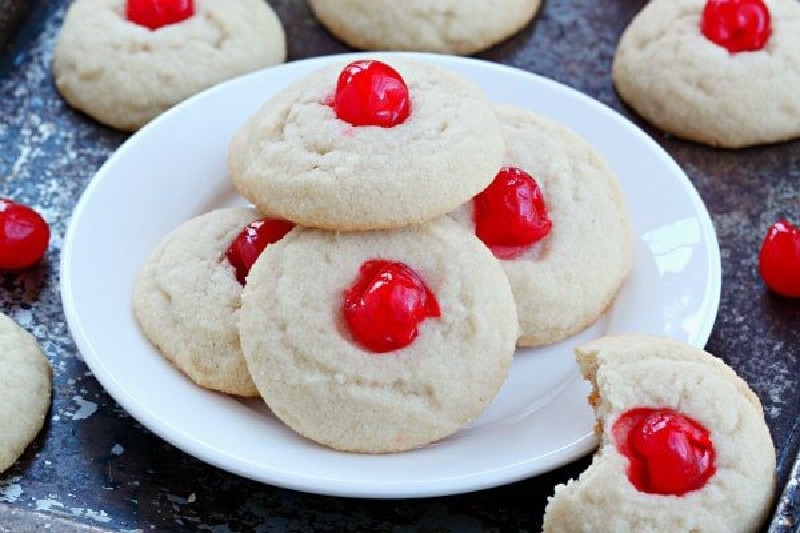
[134,55,632,452]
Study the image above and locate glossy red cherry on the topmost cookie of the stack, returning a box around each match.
[333,60,411,128]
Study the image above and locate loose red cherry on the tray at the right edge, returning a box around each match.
[758,220,800,298]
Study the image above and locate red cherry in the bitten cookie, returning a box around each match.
[612,408,716,496]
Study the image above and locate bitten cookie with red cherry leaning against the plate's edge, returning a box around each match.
[544,335,775,533]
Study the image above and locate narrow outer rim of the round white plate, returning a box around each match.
[59,52,722,499]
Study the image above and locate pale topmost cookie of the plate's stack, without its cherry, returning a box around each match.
[228,58,503,231]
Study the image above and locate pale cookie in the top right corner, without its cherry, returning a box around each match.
[613,0,800,148]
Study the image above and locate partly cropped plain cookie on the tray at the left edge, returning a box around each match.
[0,314,52,472]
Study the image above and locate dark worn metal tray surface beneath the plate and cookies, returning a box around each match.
[0,0,800,533]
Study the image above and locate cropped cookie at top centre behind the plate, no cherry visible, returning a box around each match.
[309,0,540,54]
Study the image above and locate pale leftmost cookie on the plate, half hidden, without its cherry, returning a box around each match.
[133,208,266,396]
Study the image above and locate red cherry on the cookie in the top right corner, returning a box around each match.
[700,0,772,54]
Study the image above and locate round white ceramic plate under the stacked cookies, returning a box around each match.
[61,54,720,498]
